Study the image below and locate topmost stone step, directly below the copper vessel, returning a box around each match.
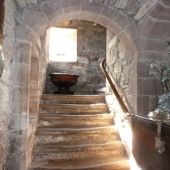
[41,94,106,104]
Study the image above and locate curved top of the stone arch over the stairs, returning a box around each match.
[13,1,138,117]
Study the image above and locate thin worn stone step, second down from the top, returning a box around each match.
[39,104,109,114]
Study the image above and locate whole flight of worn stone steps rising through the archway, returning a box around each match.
[31,95,130,170]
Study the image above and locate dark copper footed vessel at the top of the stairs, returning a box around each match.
[49,73,79,94]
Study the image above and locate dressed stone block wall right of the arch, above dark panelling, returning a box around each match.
[137,0,170,116]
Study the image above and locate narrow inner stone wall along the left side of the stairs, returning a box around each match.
[26,33,48,167]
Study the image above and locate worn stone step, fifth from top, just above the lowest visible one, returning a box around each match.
[33,142,125,164]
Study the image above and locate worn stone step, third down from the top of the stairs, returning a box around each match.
[38,114,113,128]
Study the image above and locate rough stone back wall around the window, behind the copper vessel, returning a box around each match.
[46,20,106,94]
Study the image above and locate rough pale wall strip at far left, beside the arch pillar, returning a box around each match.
[0,0,18,170]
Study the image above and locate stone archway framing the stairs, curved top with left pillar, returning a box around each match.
[8,1,138,170]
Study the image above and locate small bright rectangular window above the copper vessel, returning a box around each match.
[47,27,77,62]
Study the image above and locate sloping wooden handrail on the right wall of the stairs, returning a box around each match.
[100,59,132,114]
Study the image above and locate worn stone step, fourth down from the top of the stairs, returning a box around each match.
[36,126,118,146]
